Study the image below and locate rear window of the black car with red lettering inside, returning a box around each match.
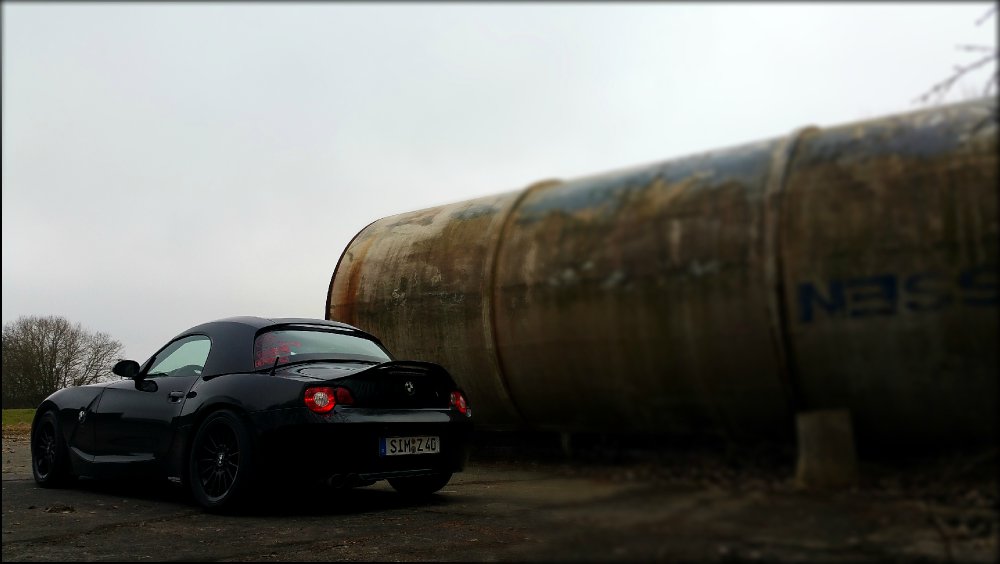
[253,329,392,368]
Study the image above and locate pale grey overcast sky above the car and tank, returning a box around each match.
[3,2,997,361]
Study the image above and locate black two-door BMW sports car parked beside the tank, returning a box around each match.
[31,317,472,509]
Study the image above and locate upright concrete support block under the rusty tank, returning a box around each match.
[795,409,858,489]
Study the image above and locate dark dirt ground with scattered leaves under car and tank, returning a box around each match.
[3,435,1000,562]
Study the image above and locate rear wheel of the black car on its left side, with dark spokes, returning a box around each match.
[188,410,254,511]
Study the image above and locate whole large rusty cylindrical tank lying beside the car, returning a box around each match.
[327,100,998,445]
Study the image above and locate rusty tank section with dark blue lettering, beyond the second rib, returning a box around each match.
[781,104,1000,443]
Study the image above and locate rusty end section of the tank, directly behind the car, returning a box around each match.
[327,192,520,424]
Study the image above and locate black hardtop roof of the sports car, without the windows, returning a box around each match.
[157,316,382,376]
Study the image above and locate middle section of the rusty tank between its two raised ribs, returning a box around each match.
[494,139,787,433]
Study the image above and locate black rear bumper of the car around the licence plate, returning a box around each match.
[250,406,472,481]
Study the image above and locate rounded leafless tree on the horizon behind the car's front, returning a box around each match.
[2,316,122,408]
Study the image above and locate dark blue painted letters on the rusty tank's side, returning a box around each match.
[797,264,997,323]
